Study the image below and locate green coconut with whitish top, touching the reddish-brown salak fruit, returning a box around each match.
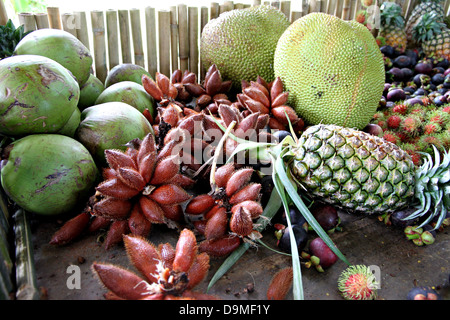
[75,102,153,167]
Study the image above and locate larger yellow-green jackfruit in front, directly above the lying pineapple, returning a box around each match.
[274,13,385,129]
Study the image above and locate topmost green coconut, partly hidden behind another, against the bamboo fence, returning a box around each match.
[14,29,93,86]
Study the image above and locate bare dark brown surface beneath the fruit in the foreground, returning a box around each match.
[32,208,450,301]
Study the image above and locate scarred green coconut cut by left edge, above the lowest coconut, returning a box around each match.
[0,55,80,136]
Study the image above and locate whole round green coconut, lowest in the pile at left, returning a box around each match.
[1,134,99,215]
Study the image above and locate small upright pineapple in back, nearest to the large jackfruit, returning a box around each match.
[378,2,407,52]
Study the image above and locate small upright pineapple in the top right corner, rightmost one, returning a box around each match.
[413,11,450,59]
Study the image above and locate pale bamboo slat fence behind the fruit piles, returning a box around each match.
[0,0,450,81]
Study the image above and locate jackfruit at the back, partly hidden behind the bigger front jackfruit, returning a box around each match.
[200,5,290,88]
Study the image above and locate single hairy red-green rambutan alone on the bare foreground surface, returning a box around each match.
[338,265,378,300]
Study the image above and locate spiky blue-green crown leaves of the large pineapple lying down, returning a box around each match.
[405,146,450,229]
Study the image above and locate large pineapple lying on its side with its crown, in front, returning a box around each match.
[283,124,450,225]
